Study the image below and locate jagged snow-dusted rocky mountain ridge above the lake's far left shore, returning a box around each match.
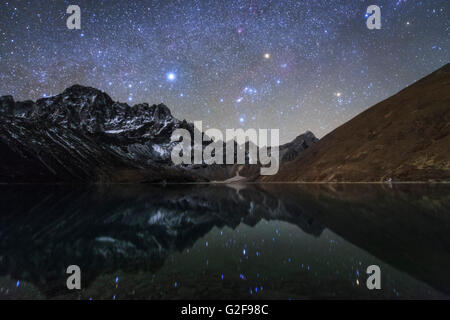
[0,85,317,182]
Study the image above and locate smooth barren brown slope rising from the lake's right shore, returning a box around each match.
[259,64,450,182]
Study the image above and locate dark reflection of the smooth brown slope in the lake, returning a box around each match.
[268,184,450,293]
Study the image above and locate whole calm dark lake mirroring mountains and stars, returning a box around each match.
[0,184,450,299]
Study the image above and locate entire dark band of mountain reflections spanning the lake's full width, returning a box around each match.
[0,185,450,297]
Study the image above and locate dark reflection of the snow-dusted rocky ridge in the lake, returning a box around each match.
[0,186,323,293]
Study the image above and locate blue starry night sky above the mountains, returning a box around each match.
[0,0,450,143]
